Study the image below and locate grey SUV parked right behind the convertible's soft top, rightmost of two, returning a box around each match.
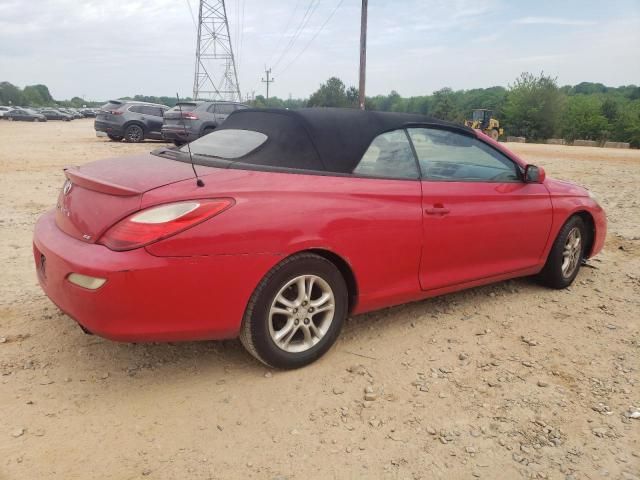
[162,101,249,145]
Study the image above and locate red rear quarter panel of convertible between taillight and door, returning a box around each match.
[143,170,422,312]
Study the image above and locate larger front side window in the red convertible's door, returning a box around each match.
[408,128,520,182]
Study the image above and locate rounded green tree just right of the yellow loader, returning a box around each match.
[504,72,564,140]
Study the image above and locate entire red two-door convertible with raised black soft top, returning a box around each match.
[33,109,606,368]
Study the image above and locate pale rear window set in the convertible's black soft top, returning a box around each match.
[180,129,267,160]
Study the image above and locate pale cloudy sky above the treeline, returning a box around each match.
[0,0,640,100]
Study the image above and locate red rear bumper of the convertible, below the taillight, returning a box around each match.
[33,212,277,341]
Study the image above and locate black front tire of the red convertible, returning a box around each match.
[538,216,588,289]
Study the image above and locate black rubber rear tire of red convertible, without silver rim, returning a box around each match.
[240,253,349,369]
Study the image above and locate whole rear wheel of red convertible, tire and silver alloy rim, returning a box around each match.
[240,253,348,369]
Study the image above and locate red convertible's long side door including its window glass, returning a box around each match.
[408,128,552,290]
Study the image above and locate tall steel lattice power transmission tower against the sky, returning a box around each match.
[193,0,242,101]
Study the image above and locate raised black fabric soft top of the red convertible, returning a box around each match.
[218,108,475,173]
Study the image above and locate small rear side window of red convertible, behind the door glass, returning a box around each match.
[353,130,419,178]
